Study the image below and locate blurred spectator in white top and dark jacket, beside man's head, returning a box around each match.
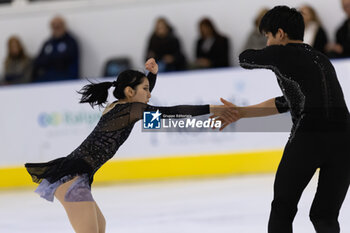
[300,5,328,53]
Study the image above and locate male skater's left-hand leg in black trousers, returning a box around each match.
[268,135,318,233]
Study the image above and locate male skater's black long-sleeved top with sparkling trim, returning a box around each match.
[239,43,350,135]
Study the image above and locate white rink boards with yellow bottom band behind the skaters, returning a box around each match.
[0,60,350,188]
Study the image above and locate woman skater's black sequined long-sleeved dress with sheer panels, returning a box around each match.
[25,73,209,198]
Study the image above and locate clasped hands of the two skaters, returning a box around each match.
[210,98,241,131]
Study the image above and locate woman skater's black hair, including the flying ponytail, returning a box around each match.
[78,70,147,107]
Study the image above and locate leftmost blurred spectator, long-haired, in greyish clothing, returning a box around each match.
[3,36,32,85]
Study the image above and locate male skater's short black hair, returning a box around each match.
[259,6,305,40]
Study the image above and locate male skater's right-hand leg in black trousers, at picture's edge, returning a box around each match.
[310,134,350,233]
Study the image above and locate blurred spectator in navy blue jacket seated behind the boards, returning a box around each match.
[33,16,79,82]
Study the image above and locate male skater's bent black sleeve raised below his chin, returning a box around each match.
[239,45,281,69]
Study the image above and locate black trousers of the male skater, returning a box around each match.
[268,130,350,233]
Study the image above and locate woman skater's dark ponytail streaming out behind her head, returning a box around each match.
[78,82,113,107]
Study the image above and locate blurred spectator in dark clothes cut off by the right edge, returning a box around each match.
[326,0,350,58]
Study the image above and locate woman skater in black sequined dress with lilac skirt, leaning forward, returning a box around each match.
[25,58,225,233]
